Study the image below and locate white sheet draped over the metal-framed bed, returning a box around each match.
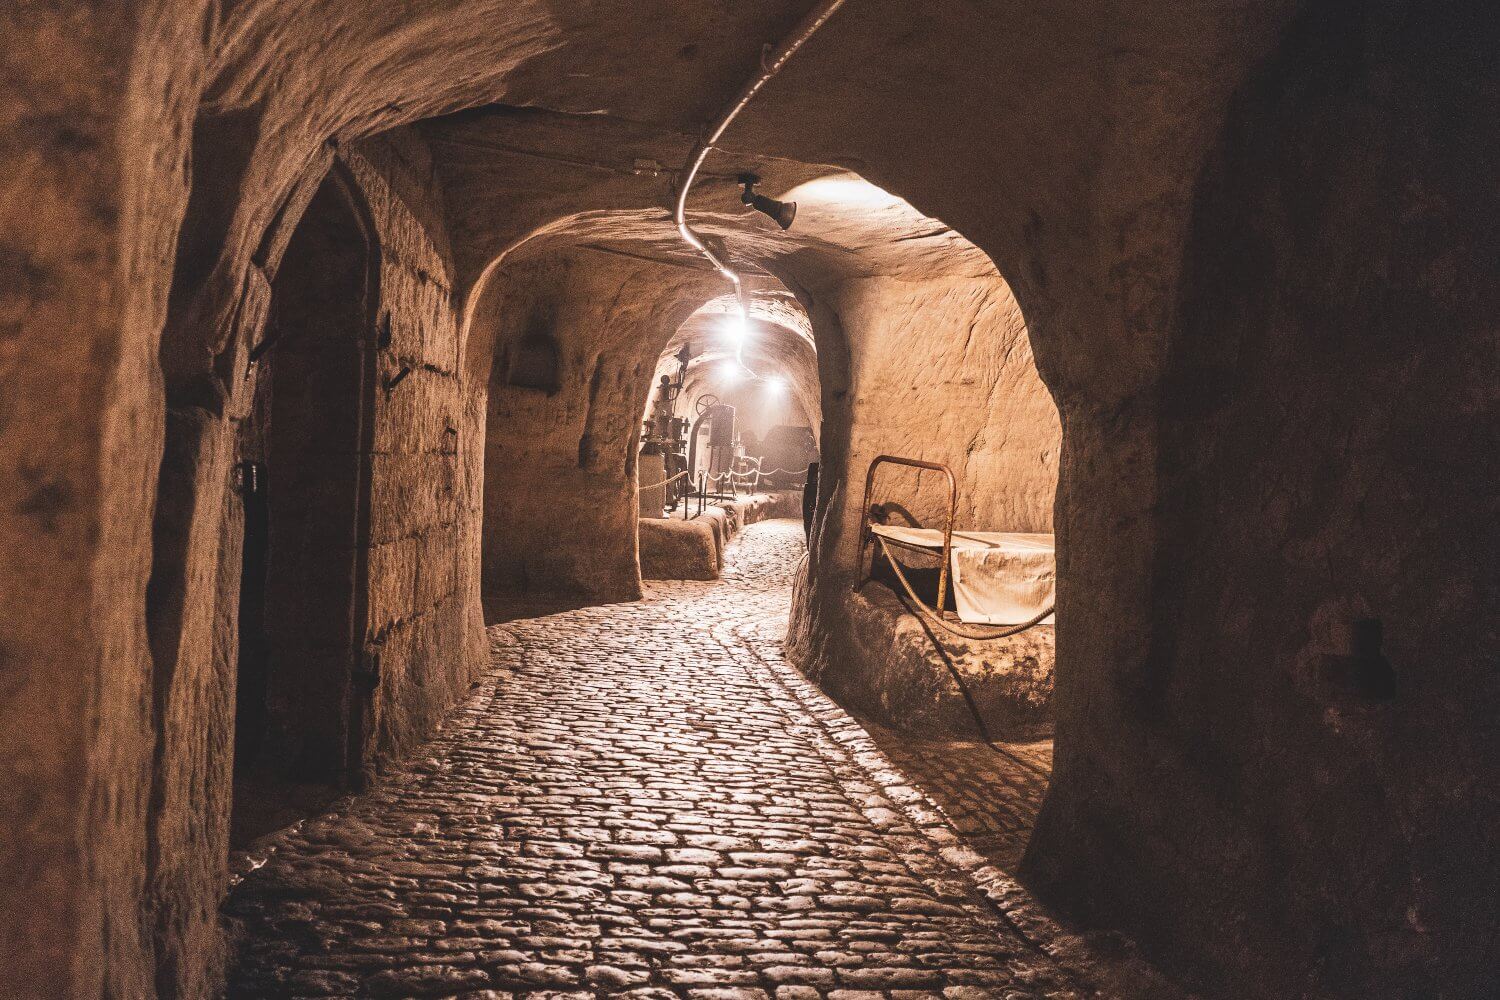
[870,525,1058,625]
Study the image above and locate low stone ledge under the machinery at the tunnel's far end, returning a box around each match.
[641,490,803,580]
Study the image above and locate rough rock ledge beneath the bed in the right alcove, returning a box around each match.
[792,569,1056,741]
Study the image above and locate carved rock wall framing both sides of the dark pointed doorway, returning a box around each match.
[143,134,485,996]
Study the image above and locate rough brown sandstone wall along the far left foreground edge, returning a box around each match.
[0,3,206,997]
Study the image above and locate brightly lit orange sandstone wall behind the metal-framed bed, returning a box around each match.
[815,277,1062,538]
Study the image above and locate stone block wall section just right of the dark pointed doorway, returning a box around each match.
[347,138,485,763]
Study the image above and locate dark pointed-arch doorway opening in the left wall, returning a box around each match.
[234,171,380,837]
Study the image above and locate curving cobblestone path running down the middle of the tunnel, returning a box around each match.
[225,522,1119,1000]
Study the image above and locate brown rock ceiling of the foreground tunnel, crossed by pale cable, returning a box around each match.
[183,0,1304,393]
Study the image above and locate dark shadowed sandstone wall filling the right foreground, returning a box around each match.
[1028,4,1500,997]
